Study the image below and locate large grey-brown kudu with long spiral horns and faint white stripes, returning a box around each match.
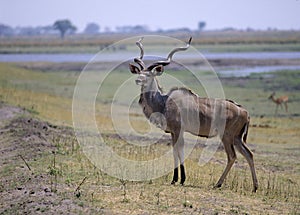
[129,38,258,192]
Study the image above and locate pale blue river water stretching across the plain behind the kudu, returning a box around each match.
[0,51,300,77]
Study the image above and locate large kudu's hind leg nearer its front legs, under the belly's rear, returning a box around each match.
[214,137,236,188]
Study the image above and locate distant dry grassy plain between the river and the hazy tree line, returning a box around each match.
[0,31,300,53]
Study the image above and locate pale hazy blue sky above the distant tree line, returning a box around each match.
[0,0,300,31]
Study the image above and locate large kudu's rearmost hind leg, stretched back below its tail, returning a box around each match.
[234,137,258,192]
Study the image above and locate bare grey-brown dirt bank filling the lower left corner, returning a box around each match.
[0,103,100,214]
